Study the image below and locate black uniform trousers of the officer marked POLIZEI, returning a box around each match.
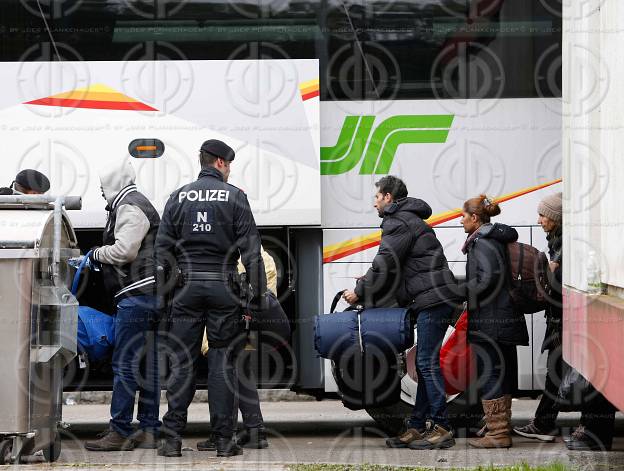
[163,281,244,438]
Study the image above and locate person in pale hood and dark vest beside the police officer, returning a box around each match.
[85,160,161,451]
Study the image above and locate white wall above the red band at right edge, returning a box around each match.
[562,0,624,290]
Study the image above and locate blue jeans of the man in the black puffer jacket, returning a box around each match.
[408,305,453,430]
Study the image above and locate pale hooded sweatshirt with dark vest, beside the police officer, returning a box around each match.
[93,160,160,301]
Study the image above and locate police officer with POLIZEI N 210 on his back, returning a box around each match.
[155,139,266,457]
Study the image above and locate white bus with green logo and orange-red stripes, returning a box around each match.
[0,0,561,436]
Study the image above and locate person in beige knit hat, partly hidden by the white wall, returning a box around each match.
[514,193,563,442]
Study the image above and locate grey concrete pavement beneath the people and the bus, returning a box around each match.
[12,400,624,471]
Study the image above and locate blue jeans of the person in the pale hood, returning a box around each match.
[110,296,160,437]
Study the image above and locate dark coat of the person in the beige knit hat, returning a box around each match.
[542,226,563,352]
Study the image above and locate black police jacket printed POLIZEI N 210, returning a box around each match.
[154,168,266,298]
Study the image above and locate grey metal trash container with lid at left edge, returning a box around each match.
[0,195,80,464]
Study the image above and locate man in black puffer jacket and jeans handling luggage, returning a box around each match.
[344,175,462,449]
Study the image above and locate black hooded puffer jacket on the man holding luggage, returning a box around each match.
[355,198,463,311]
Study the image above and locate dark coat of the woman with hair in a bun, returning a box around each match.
[466,223,529,345]
